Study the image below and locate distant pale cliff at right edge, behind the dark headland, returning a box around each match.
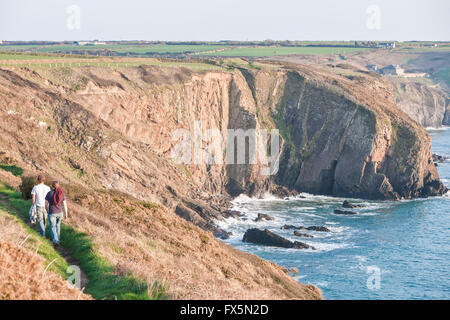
[392,81,448,128]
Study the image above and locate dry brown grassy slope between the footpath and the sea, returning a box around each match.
[69,193,321,299]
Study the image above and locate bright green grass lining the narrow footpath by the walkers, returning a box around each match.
[0,180,159,299]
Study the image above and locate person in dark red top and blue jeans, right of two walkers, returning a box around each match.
[45,181,69,247]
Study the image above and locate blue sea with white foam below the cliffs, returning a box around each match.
[221,128,450,299]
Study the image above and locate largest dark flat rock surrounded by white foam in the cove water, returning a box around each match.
[242,228,315,250]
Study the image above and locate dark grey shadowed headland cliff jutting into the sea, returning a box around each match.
[243,67,446,199]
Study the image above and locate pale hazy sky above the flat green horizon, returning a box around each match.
[0,0,450,41]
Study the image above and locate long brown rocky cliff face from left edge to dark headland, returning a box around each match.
[3,64,445,205]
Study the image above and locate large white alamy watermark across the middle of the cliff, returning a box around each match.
[171,121,280,176]
